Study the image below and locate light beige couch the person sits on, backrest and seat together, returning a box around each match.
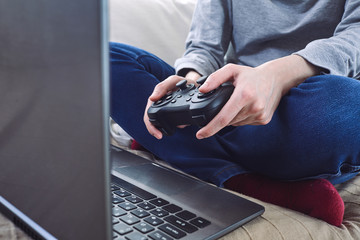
[110,0,360,240]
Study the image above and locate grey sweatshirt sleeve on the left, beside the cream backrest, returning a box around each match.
[175,0,232,75]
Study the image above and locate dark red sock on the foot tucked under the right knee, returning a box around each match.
[225,174,344,226]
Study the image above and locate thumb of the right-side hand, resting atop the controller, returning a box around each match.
[199,64,236,93]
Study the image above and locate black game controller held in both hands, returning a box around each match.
[147,76,234,136]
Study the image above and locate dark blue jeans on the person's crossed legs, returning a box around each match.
[110,43,360,186]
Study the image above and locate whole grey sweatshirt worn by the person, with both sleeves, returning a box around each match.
[175,0,360,78]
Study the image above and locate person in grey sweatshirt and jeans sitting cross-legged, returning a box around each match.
[110,0,360,226]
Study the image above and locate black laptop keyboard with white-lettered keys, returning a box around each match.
[111,179,211,240]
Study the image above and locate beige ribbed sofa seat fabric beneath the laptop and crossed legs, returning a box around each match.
[0,139,360,240]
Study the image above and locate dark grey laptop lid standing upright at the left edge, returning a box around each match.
[0,0,111,239]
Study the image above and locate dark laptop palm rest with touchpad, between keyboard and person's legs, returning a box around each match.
[112,148,264,231]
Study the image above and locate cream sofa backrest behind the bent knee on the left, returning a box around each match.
[109,0,196,66]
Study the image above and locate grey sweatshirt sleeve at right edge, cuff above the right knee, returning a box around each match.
[294,0,360,78]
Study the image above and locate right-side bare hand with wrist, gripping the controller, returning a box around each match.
[196,55,319,139]
